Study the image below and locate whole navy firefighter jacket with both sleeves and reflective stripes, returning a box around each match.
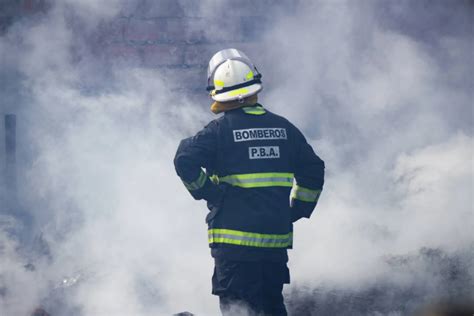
[174,104,324,261]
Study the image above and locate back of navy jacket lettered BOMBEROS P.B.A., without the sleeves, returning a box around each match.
[208,105,295,260]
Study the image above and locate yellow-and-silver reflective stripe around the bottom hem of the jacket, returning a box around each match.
[208,228,293,248]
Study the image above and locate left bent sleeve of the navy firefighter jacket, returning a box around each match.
[174,121,222,203]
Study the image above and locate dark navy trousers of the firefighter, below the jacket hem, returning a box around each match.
[212,258,290,316]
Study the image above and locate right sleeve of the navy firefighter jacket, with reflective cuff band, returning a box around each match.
[291,123,324,222]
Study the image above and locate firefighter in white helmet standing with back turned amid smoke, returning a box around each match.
[174,49,324,315]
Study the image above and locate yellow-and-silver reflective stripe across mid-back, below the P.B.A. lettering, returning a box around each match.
[219,172,293,188]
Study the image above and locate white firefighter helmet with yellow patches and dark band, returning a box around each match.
[207,48,262,102]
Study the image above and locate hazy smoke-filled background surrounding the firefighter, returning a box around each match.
[0,0,474,315]
